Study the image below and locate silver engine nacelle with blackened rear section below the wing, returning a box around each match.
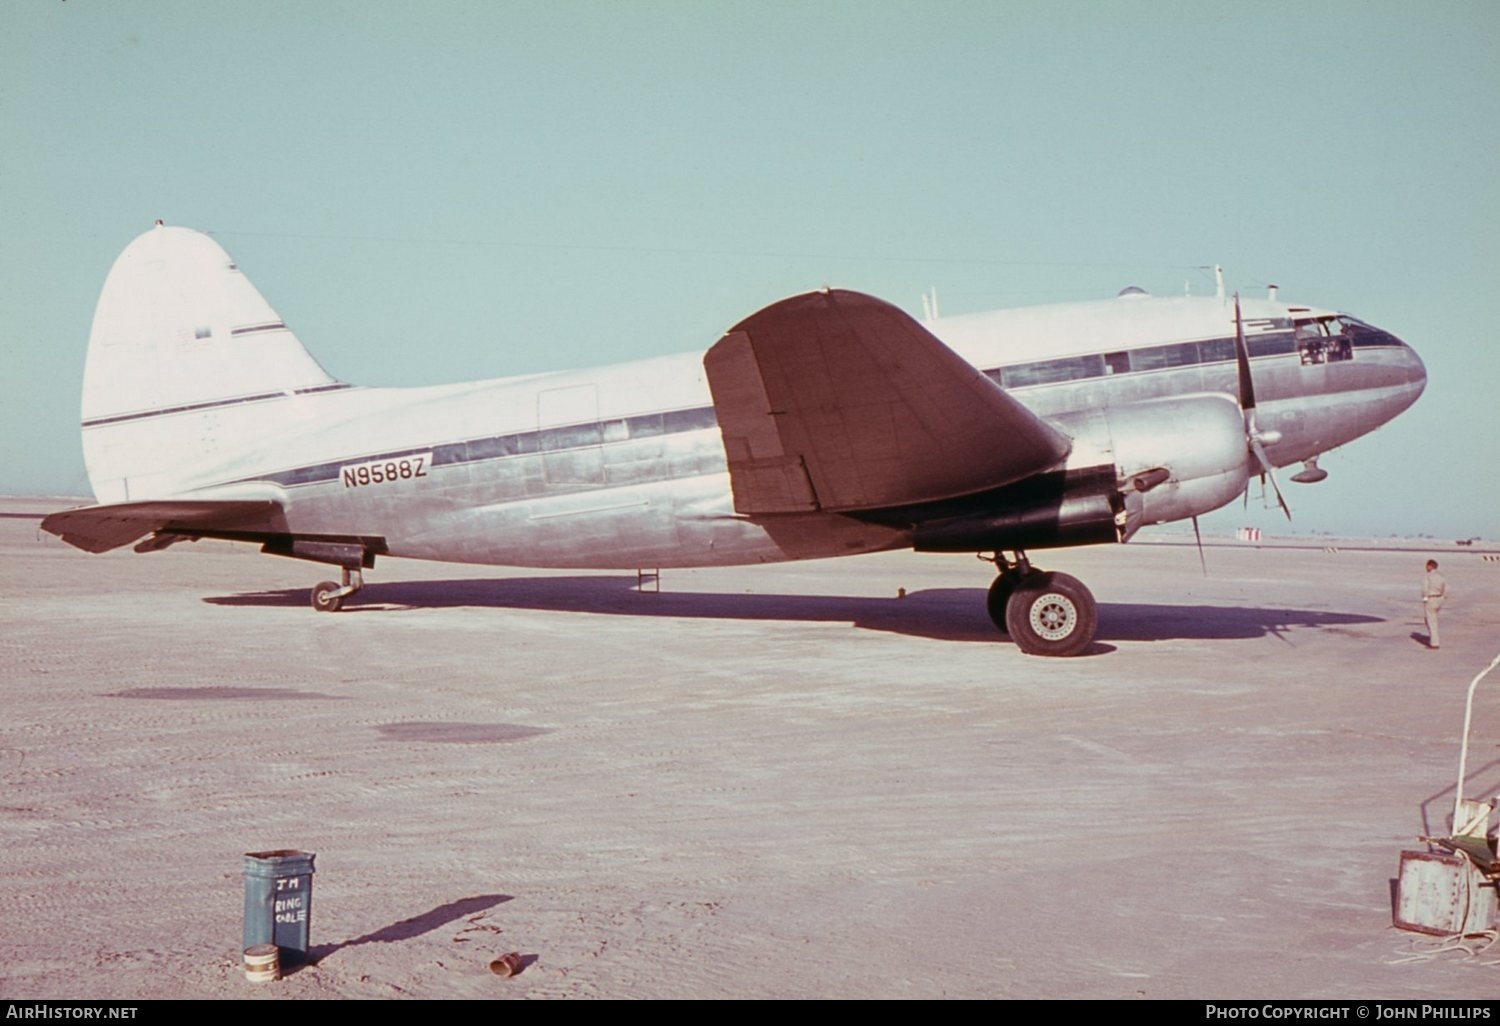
[912,393,1250,552]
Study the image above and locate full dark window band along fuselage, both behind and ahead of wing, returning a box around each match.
[266,326,1401,485]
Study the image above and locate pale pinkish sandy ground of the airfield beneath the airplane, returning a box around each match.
[0,504,1500,999]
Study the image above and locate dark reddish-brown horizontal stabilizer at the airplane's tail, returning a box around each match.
[42,500,287,552]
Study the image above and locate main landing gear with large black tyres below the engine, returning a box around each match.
[980,552,1098,656]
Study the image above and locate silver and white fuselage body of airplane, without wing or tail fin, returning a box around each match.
[99,297,1425,569]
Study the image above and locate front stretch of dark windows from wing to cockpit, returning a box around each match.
[986,324,1401,389]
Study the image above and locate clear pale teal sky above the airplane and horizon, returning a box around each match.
[0,0,1500,539]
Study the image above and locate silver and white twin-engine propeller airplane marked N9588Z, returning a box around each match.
[42,222,1427,656]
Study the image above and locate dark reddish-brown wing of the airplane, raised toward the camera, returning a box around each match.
[704,290,1070,515]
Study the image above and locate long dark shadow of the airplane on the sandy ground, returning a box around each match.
[204,575,1383,648]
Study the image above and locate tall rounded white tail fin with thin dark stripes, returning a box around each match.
[83,222,345,503]
